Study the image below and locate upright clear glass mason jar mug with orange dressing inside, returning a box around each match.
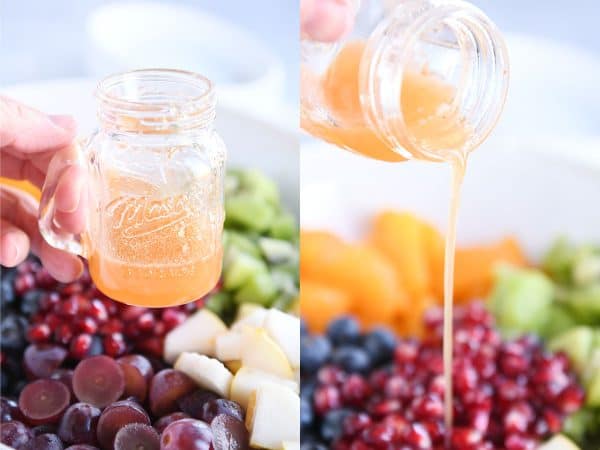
[40,70,226,307]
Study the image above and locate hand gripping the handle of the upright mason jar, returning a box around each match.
[0,96,87,282]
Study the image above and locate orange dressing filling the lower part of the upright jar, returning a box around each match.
[88,174,222,307]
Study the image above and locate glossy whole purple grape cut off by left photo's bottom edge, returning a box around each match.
[160,419,212,450]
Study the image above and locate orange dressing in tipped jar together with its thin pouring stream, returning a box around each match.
[302,41,471,436]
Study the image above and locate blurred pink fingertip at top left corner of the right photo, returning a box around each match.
[300,0,356,42]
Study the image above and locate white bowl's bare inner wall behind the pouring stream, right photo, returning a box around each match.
[300,141,600,258]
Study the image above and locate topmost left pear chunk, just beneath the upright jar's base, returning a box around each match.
[163,309,227,364]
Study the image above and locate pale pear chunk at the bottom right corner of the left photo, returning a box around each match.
[246,383,300,450]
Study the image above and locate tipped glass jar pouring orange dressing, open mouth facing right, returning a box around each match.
[301,0,508,161]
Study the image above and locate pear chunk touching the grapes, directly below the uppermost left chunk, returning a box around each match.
[174,352,233,398]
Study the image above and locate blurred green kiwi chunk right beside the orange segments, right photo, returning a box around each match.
[489,266,554,337]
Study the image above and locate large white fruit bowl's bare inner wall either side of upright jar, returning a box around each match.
[0,79,299,214]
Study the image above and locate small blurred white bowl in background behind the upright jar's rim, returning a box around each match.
[86,1,284,116]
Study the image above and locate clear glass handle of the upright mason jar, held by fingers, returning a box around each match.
[38,140,89,258]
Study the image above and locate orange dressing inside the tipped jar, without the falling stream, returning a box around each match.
[302,41,468,162]
